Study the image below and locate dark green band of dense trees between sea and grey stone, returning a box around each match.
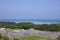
[0,22,60,31]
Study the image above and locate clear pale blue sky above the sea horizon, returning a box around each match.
[0,0,60,19]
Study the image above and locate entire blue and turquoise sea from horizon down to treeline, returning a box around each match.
[0,19,60,24]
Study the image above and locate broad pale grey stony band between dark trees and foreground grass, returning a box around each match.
[0,30,60,39]
